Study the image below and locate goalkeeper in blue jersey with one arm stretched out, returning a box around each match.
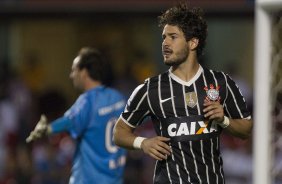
[26,47,126,184]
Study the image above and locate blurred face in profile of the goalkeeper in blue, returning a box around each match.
[70,56,83,89]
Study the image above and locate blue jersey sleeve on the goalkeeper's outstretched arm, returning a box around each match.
[64,95,91,139]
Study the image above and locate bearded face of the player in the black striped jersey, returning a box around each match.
[162,24,189,66]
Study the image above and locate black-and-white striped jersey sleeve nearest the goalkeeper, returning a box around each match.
[121,82,150,128]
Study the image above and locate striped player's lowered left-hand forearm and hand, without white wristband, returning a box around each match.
[114,118,170,160]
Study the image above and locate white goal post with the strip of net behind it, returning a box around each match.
[253,0,282,184]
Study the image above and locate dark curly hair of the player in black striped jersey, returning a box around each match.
[158,3,207,56]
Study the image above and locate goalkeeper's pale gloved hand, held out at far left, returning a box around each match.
[26,114,48,143]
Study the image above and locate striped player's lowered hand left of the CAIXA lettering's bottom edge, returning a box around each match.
[141,136,171,160]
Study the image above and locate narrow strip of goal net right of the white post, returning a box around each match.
[270,12,282,183]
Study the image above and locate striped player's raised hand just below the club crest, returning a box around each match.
[203,101,224,122]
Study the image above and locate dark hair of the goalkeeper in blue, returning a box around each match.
[78,47,111,85]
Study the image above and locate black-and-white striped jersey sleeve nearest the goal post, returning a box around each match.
[223,75,251,119]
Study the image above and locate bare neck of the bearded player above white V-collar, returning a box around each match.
[171,56,200,82]
